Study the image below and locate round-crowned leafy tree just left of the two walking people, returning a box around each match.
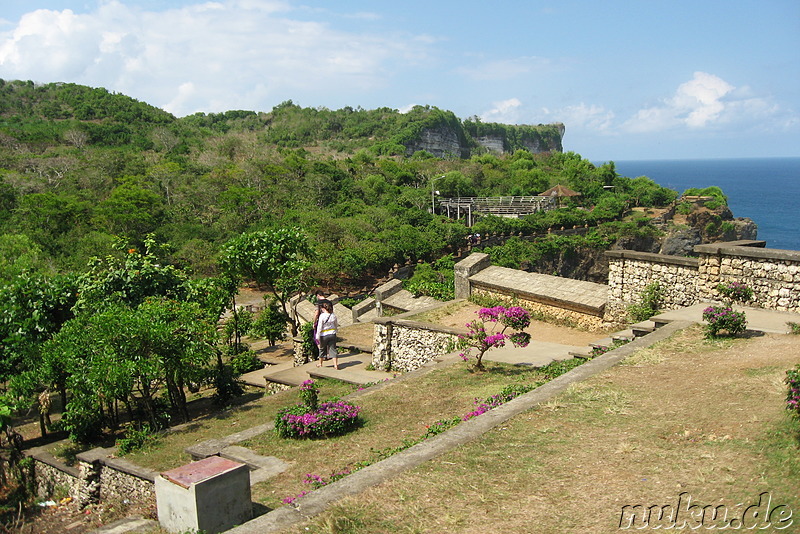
[220,228,313,336]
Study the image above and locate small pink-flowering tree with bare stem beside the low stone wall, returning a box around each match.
[459,306,531,371]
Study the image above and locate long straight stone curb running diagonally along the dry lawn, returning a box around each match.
[228,321,694,534]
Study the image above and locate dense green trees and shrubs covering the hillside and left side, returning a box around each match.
[0,80,688,454]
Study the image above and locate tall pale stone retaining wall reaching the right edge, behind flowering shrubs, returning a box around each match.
[605,241,800,322]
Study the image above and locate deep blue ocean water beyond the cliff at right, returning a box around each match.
[614,157,800,250]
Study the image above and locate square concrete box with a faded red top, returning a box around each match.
[156,456,253,534]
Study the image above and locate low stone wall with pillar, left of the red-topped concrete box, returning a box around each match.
[27,448,157,507]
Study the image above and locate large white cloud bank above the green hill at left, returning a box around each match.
[0,0,425,115]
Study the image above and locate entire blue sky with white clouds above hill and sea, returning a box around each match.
[0,0,800,161]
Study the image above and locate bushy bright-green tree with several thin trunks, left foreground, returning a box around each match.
[39,298,216,442]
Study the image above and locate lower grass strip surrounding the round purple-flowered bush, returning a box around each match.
[127,356,580,508]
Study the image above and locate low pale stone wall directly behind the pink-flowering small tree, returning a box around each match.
[372,317,467,372]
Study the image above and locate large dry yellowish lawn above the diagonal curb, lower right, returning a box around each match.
[284,327,800,533]
